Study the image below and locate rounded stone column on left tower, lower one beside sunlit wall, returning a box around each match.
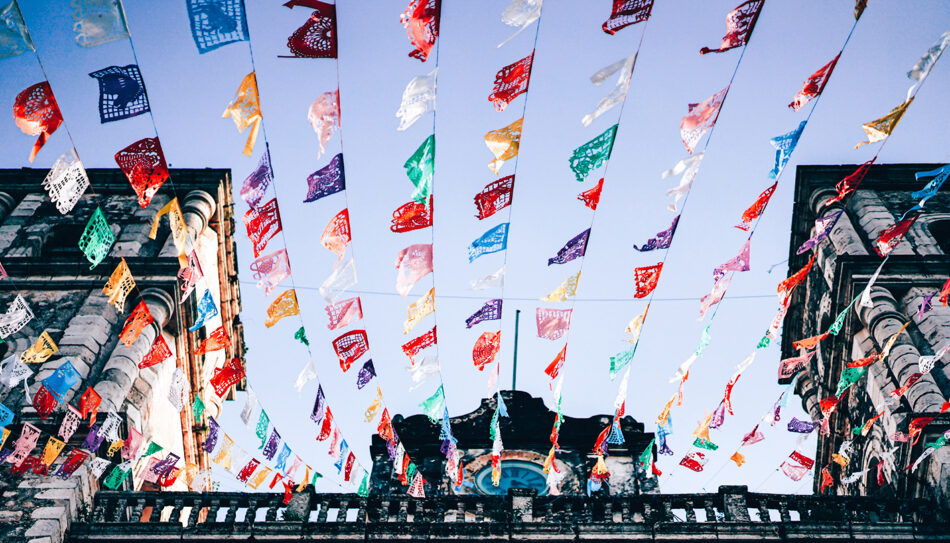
[93,288,175,413]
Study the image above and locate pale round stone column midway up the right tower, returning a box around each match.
[858,286,943,413]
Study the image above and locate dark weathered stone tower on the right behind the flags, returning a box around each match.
[780,164,950,504]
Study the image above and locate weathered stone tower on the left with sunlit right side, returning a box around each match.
[0,169,243,542]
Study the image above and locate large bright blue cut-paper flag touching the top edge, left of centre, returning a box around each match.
[187,0,248,55]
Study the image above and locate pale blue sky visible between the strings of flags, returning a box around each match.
[0,0,950,492]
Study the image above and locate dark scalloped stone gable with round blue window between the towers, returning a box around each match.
[370,390,657,496]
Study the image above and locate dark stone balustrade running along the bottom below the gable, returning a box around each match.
[68,487,950,541]
